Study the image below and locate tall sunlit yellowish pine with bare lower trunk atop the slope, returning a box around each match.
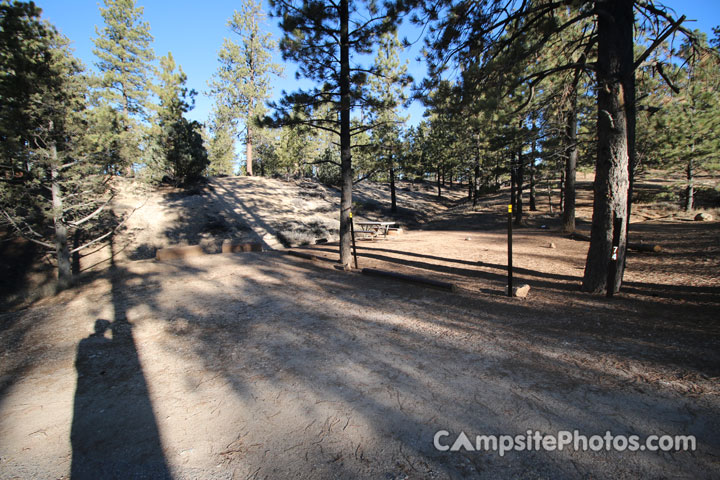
[210,0,282,175]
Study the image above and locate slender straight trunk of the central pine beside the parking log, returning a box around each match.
[339,0,353,269]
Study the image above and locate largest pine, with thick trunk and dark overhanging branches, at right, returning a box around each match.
[425,0,687,294]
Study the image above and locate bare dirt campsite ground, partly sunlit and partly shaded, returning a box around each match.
[0,174,720,479]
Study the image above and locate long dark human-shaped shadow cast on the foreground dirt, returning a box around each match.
[70,315,172,479]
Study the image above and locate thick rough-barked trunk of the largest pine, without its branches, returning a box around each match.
[582,0,634,293]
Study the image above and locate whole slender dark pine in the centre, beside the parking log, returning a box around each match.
[270,0,408,268]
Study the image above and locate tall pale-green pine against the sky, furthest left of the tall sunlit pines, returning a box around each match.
[93,0,155,176]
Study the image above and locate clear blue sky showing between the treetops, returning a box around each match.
[40,0,720,128]
